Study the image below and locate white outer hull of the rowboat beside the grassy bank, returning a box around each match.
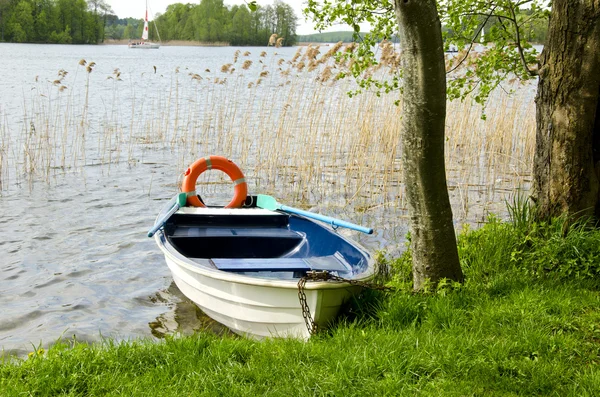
[157,237,360,340]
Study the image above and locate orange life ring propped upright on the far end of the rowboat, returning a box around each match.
[181,156,248,208]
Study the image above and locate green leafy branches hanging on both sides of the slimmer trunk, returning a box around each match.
[304,0,549,105]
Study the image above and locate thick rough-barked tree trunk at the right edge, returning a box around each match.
[532,0,600,218]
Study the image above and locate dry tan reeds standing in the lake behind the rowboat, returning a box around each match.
[0,43,535,226]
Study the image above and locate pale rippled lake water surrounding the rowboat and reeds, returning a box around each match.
[0,43,530,355]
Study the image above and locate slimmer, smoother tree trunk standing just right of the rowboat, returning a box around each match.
[395,0,463,290]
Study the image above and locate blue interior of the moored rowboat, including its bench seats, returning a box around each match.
[164,212,368,277]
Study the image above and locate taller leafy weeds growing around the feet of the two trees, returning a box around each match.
[386,200,600,292]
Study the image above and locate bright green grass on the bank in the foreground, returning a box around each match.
[0,215,600,396]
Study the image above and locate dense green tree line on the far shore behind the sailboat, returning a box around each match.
[0,0,298,46]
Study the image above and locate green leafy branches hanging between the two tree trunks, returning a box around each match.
[439,0,549,104]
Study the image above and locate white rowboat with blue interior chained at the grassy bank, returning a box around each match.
[148,156,374,340]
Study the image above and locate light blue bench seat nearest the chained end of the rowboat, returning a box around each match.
[212,255,350,272]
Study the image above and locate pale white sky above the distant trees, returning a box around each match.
[106,0,338,34]
